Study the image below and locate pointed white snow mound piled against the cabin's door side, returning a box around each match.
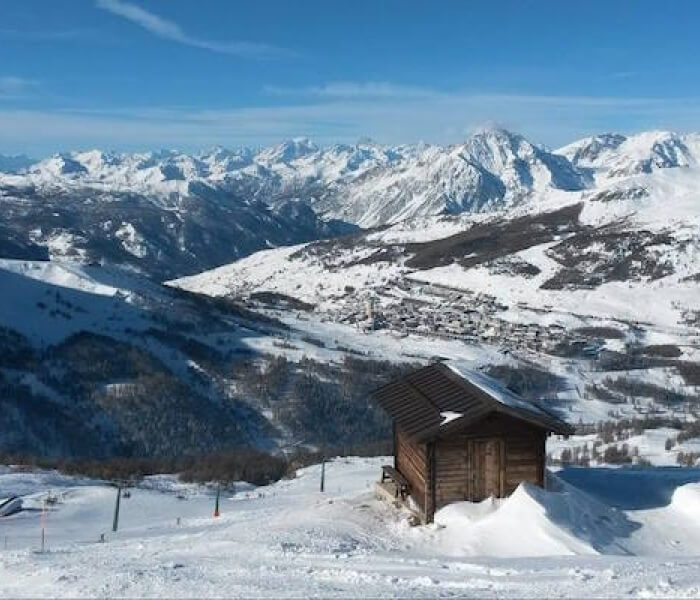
[432,482,634,557]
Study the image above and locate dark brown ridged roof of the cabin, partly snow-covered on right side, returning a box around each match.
[372,361,573,441]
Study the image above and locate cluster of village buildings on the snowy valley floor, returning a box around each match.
[284,278,624,359]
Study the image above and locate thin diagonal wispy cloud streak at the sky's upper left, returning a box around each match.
[97,0,294,59]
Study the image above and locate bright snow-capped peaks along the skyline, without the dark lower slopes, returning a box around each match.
[0,129,700,227]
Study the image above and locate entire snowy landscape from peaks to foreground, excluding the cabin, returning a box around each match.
[0,129,700,598]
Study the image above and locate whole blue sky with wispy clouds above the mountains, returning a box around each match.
[0,0,700,156]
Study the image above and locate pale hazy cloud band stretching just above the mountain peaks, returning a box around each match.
[0,86,700,156]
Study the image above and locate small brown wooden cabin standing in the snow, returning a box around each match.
[373,361,573,523]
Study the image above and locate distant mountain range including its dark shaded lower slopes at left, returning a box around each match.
[0,129,700,279]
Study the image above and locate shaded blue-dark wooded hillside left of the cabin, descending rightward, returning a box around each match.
[0,259,448,458]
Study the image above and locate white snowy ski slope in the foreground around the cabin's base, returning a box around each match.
[0,457,700,598]
